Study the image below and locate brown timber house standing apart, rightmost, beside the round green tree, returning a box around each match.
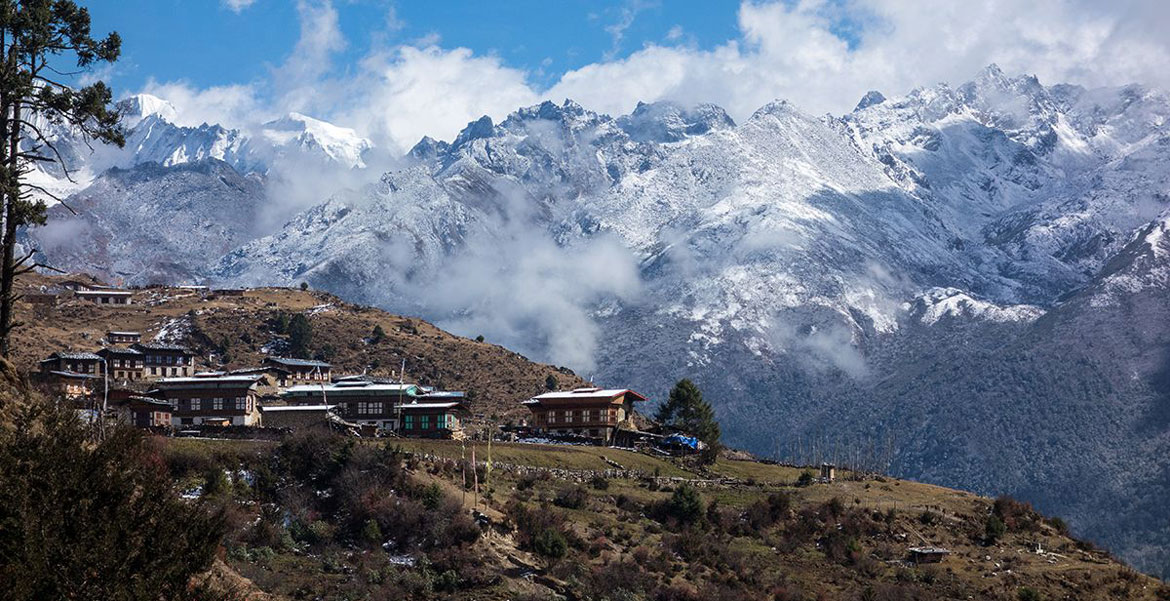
[524,388,646,444]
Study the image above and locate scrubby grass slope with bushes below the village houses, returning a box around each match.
[166,437,1170,601]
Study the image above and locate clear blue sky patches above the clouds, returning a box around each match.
[89,0,738,90]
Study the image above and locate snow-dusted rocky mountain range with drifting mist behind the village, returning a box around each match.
[28,65,1170,574]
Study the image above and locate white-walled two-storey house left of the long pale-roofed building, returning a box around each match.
[154,374,264,426]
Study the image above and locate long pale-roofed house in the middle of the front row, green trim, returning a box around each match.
[281,381,419,431]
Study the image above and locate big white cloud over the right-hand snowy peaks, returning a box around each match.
[548,0,1170,119]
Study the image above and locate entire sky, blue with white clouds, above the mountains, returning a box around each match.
[77,0,1170,151]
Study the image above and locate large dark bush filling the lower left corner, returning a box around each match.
[0,405,226,601]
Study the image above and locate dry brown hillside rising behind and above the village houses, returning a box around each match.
[13,275,584,419]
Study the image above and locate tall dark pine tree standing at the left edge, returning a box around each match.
[0,0,125,357]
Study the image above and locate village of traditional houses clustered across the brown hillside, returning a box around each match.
[26,271,683,451]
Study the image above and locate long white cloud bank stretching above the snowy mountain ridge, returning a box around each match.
[148,0,1170,153]
